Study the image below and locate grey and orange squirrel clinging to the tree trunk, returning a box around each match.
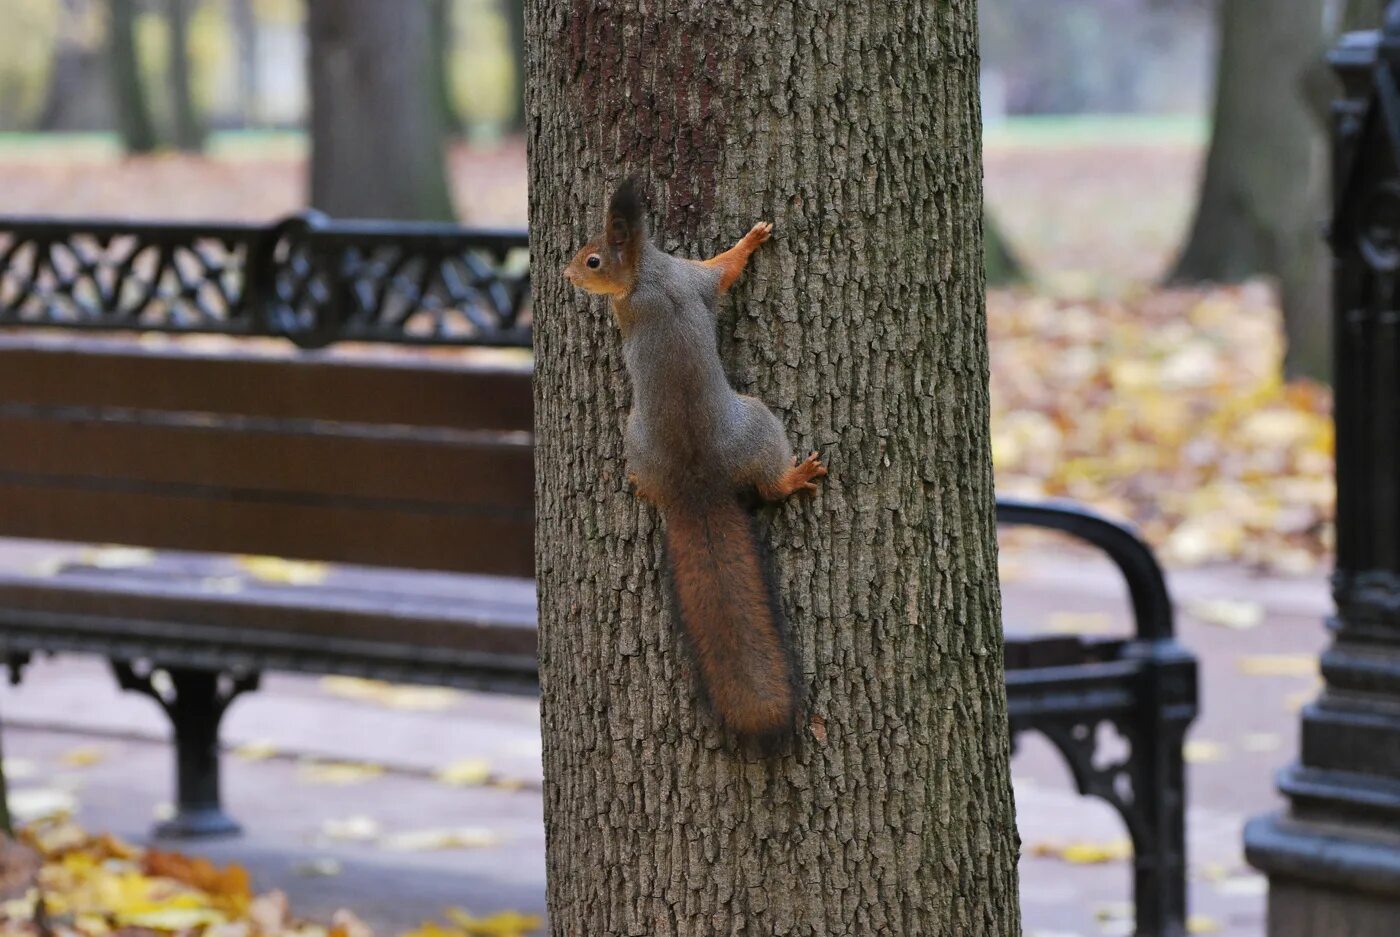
[564,179,826,744]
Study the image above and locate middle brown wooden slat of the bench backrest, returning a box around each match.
[0,403,535,507]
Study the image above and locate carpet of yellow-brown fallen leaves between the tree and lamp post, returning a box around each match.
[988,284,1334,574]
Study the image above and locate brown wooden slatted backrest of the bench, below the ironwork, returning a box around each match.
[0,332,533,576]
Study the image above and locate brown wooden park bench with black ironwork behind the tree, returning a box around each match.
[0,214,1196,934]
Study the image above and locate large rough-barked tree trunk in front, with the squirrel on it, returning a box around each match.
[526,0,1019,937]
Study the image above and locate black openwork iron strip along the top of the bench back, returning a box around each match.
[0,213,531,347]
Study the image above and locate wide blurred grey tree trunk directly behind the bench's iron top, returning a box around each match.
[307,0,452,220]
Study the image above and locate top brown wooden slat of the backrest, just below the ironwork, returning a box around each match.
[0,335,533,433]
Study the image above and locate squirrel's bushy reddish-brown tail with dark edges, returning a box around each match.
[665,497,798,742]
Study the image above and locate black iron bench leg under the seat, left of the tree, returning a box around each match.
[112,661,258,839]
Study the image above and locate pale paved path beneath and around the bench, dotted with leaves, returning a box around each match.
[0,556,1329,937]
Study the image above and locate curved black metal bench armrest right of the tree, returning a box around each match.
[997,497,1175,641]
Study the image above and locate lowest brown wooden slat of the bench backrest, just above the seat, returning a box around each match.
[0,478,535,576]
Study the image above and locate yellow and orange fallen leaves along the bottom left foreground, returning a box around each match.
[0,818,540,937]
